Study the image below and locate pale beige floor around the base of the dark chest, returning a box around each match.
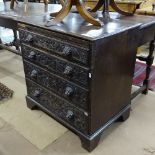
[0,51,155,155]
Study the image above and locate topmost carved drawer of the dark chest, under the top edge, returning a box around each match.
[19,29,89,65]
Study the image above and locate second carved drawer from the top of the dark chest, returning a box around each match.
[22,44,89,87]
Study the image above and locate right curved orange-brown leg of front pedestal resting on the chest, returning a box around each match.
[75,0,103,26]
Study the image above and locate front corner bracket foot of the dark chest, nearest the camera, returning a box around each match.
[80,134,101,152]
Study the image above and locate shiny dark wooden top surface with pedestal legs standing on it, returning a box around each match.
[0,3,155,40]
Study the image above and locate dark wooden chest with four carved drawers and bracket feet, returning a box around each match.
[19,14,140,151]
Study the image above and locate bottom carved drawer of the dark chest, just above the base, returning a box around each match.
[26,79,88,133]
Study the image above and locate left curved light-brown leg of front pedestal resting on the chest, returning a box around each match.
[45,0,72,27]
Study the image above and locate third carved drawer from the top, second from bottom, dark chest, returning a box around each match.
[24,61,88,110]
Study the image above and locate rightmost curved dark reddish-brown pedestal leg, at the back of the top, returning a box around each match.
[110,0,134,16]
